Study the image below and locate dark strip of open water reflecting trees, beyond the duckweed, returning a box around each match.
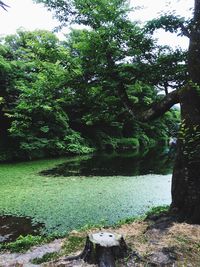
[42,149,173,176]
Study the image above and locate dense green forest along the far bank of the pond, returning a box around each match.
[0,6,183,161]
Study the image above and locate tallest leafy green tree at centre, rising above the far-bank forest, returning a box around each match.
[61,1,183,151]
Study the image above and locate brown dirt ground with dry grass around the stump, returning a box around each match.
[0,215,200,267]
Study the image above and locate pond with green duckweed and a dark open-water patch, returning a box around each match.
[0,151,171,243]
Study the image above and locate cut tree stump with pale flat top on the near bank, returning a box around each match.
[80,232,128,267]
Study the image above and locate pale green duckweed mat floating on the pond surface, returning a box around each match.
[0,159,171,235]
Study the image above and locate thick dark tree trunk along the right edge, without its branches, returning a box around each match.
[171,0,200,223]
